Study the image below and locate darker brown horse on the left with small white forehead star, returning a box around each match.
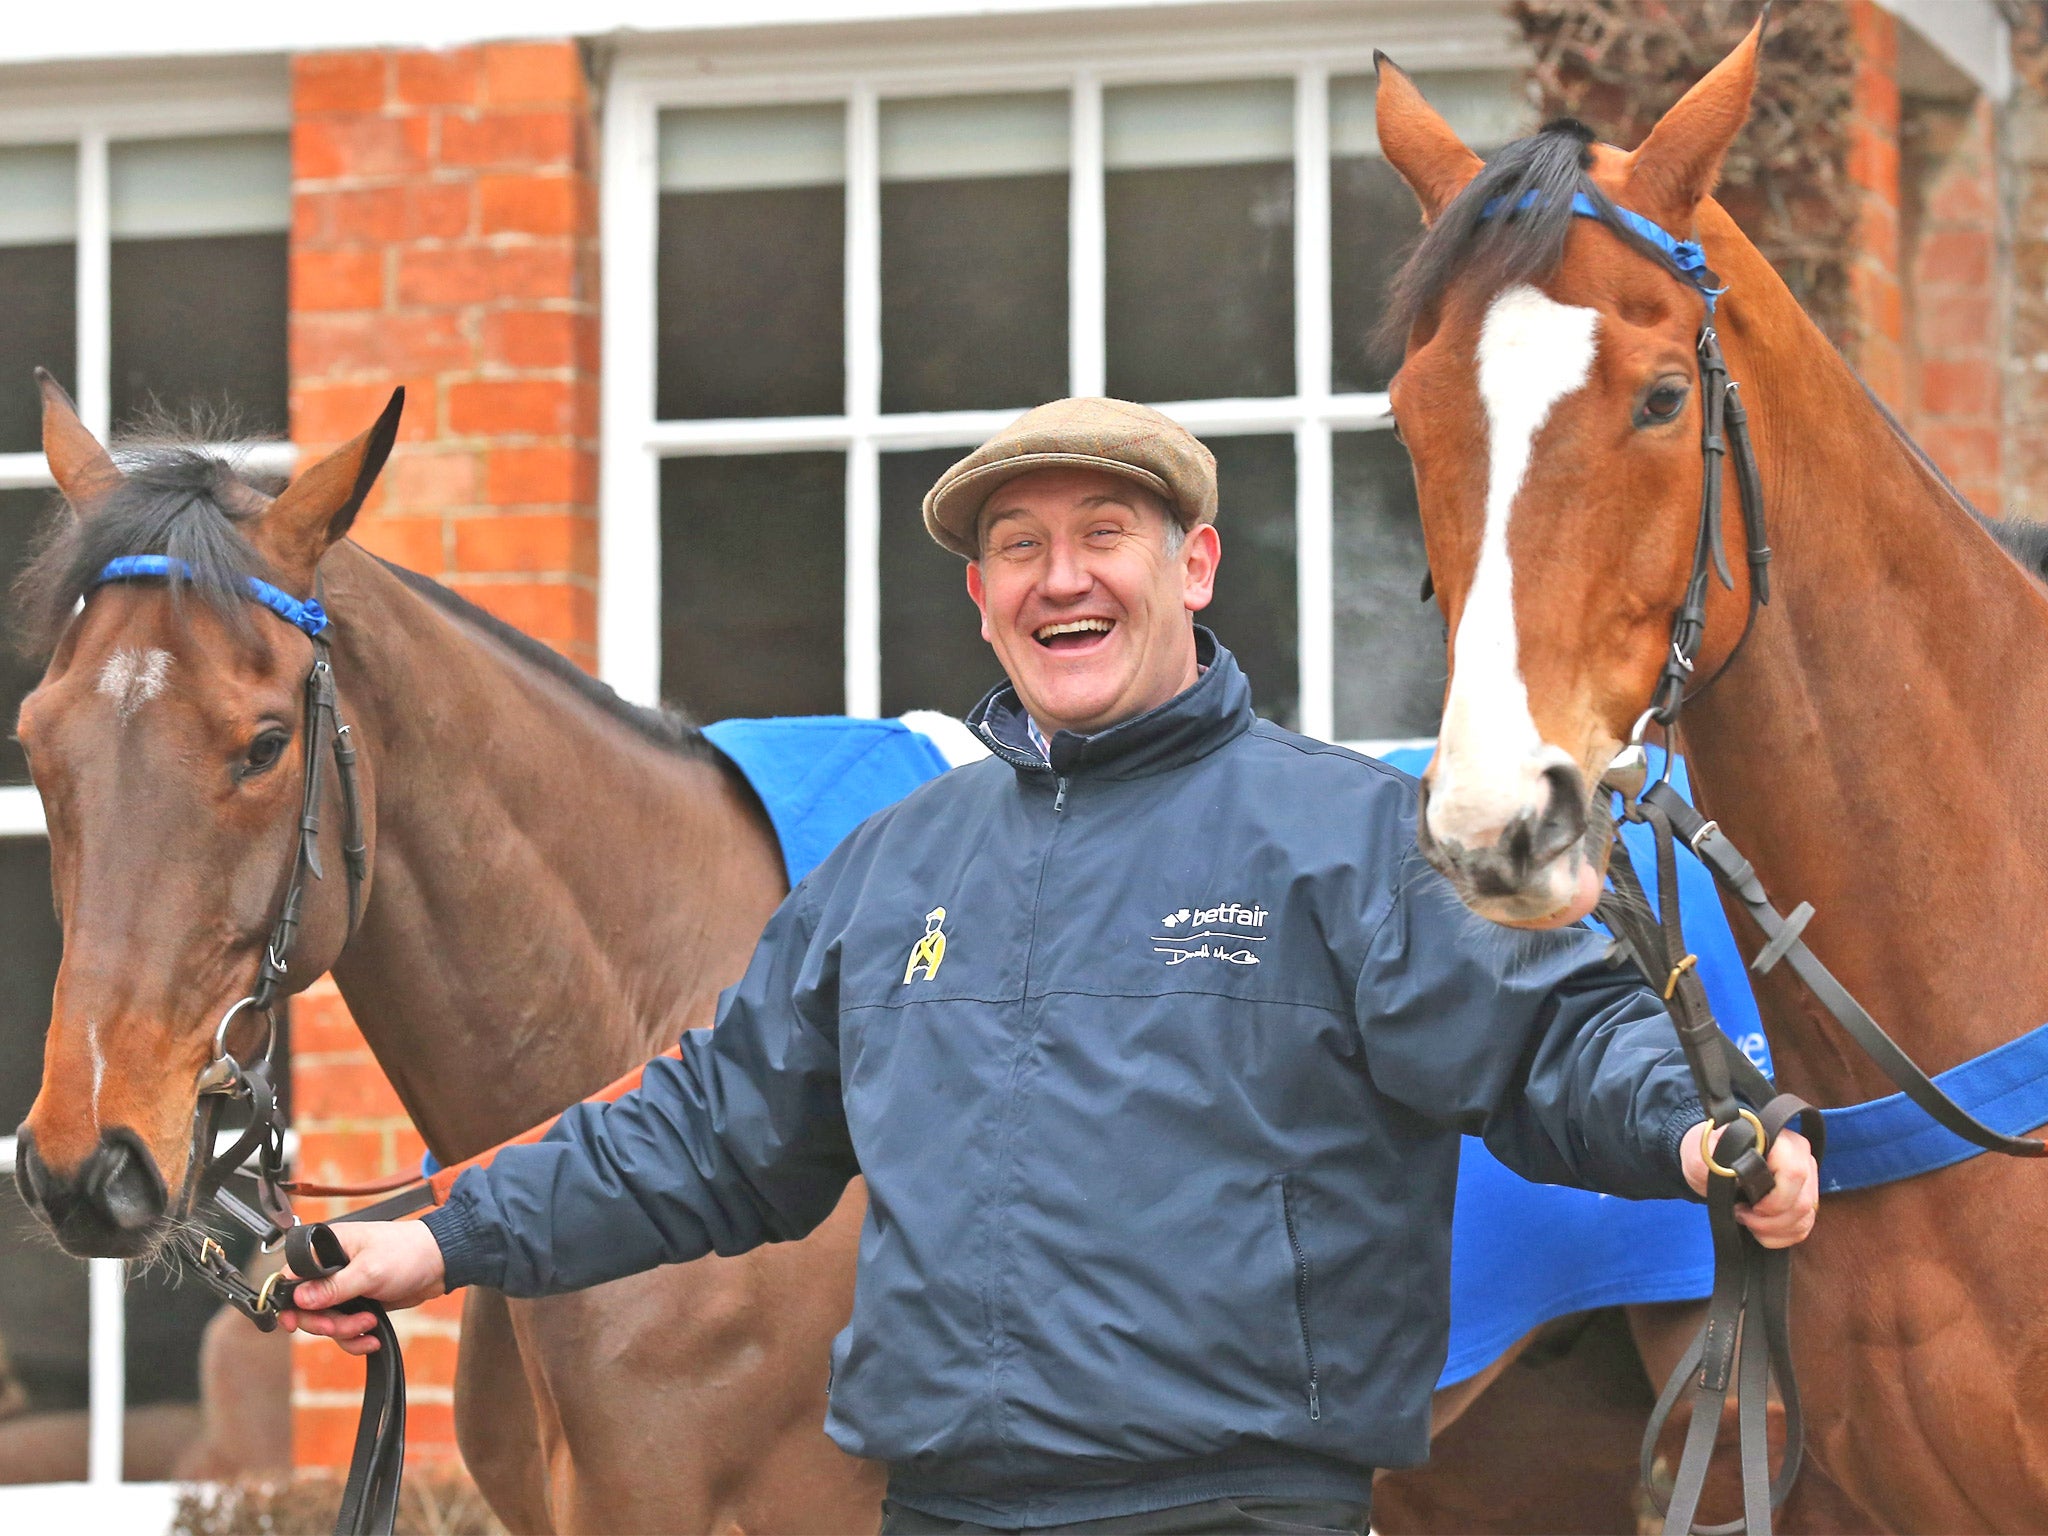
[18,383,1728,1532]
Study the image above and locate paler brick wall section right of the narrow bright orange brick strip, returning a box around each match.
[1901,96,2005,514]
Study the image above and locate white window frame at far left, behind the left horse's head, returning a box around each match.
[0,59,295,1485]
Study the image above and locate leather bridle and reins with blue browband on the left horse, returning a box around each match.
[94,555,406,1536]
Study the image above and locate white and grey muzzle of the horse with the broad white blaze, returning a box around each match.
[1415,748,1606,928]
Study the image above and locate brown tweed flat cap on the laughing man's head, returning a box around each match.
[924,397,1217,559]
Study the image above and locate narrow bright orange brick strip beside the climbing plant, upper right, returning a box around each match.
[1847,0,1907,410]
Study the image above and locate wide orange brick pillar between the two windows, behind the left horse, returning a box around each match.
[291,41,598,1466]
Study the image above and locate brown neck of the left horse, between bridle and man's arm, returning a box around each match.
[322,545,784,1159]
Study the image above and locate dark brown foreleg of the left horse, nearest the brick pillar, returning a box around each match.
[455,1288,555,1536]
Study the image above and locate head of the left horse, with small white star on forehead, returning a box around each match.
[14,375,401,1257]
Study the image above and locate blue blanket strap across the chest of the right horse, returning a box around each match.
[1821,1024,2048,1194]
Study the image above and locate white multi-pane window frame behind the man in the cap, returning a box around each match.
[598,0,1526,739]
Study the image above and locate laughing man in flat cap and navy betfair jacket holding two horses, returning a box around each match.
[291,399,1819,1532]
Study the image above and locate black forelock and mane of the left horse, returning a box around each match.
[14,442,717,758]
